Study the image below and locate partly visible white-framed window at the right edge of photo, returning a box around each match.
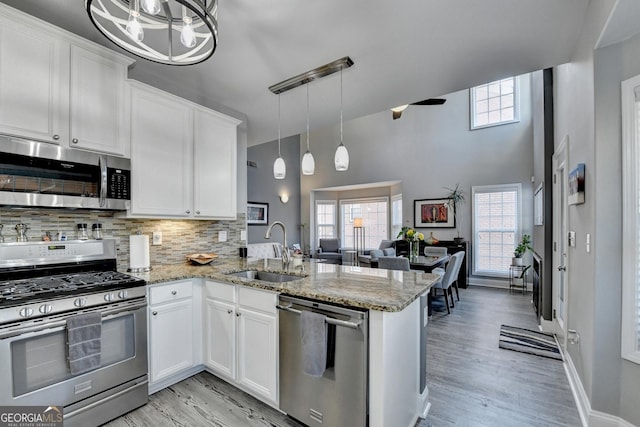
[621,76,640,364]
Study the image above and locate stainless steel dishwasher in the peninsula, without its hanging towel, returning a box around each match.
[278,295,369,427]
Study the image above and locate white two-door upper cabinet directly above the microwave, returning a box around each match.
[0,4,134,157]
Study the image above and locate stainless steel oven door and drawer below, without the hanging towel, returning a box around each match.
[0,298,147,406]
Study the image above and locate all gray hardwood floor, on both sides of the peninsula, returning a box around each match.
[107,287,580,427]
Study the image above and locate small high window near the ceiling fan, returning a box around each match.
[470,77,520,129]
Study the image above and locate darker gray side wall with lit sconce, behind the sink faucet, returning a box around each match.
[247,136,308,246]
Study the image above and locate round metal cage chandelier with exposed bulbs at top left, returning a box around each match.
[85,0,218,65]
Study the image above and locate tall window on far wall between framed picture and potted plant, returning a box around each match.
[471,184,522,276]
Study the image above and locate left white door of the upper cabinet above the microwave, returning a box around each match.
[0,17,69,143]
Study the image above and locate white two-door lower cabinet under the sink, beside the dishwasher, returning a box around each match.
[204,281,278,404]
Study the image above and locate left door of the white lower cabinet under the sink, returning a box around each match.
[204,298,236,379]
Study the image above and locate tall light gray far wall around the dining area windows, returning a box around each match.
[300,76,533,276]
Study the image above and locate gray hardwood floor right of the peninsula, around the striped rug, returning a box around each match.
[417,287,581,427]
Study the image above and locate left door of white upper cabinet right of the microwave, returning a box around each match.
[131,87,193,217]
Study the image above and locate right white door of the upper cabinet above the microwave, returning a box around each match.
[70,46,129,157]
